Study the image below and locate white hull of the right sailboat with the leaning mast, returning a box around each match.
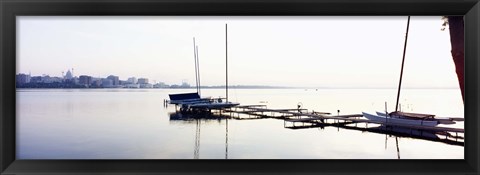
[362,112,438,126]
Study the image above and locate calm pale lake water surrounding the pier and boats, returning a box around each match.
[16,89,464,159]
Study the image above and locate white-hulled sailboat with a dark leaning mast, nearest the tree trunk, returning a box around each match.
[362,16,455,126]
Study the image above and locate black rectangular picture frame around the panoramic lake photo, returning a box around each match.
[0,0,480,174]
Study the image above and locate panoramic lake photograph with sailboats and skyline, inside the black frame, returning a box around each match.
[16,16,465,160]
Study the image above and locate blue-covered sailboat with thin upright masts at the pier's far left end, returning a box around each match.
[169,24,240,111]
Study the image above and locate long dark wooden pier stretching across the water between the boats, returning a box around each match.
[219,105,465,146]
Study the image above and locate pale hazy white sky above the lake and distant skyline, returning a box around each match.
[17,16,458,88]
